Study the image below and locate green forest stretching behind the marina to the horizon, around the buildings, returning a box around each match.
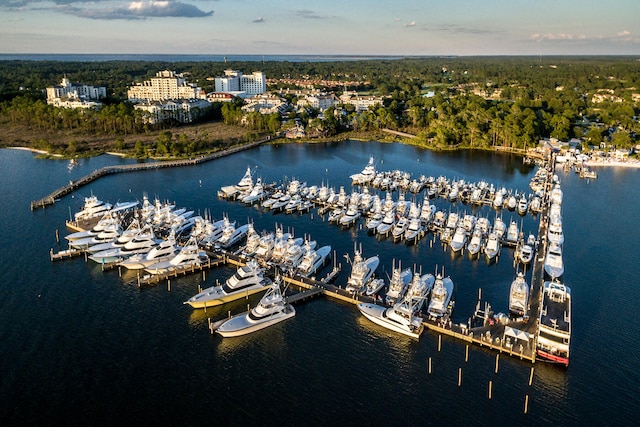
[0,56,640,154]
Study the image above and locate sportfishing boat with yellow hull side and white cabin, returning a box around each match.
[184,260,271,308]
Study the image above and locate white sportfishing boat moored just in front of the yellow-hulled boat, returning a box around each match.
[216,277,296,337]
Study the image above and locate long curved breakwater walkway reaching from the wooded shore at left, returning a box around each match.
[31,136,278,210]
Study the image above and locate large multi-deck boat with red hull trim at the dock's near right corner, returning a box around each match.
[536,281,571,366]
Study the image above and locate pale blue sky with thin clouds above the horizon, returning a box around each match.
[0,0,640,56]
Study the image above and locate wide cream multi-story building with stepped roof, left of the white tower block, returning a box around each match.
[127,70,205,103]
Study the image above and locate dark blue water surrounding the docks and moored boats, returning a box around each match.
[0,142,640,425]
